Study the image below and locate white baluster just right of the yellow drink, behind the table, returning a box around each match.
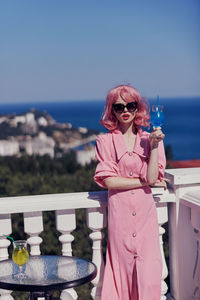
[24,211,43,255]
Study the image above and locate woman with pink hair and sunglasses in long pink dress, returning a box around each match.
[94,85,166,300]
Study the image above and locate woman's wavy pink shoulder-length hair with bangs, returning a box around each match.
[100,85,150,131]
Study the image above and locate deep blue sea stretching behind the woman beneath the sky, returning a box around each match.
[0,97,200,160]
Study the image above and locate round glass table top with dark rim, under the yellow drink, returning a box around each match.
[0,255,97,291]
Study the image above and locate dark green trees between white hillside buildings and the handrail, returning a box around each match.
[0,152,101,196]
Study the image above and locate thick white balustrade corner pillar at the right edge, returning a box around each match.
[166,168,200,300]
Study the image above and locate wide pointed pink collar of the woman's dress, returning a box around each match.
[112,129,149,160]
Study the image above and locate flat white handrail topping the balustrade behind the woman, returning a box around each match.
[0,188,175,214]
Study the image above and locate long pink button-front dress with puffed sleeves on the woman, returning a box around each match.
[94,130,166,300]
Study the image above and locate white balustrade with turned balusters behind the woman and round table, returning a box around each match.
[0,189,173,300]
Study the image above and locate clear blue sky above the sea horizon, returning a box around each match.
[0,0,200,103]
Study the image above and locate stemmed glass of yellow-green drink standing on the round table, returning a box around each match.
[12,240,29,279]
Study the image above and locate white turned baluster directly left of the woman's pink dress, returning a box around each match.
[87,207,107,300]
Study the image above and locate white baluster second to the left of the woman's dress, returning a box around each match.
[56,209,78,300]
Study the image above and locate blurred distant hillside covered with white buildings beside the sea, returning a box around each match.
[0,109,98,160]
